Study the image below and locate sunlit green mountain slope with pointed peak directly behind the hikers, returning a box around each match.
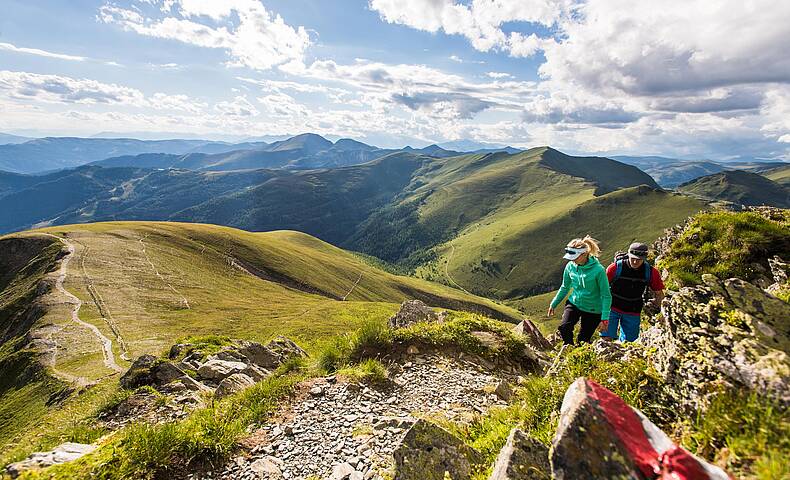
[345,147,703,299]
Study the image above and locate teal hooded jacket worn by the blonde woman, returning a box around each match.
[551,257,612,320]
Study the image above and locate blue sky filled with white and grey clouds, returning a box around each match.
[0,0,790,161]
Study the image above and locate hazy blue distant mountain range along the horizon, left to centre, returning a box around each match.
[0,133,510,174]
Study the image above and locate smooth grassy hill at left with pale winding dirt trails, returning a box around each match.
[0,222,519,458]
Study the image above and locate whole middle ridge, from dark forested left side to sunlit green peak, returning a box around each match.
[0,147,703,299]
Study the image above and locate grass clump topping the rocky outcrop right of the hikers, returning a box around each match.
[659,210,790,287]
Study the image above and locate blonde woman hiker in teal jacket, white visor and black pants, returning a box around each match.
[548,235,612,344]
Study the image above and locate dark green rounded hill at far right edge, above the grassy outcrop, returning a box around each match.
[678,170,790,208]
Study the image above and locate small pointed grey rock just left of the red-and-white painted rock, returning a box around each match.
[489,428,551,480]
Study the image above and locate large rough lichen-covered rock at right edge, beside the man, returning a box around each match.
[641,275,790,411]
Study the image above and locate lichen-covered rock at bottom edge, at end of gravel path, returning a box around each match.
[392,419,483,480]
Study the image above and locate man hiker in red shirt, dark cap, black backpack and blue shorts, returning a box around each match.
[601,243,664,342]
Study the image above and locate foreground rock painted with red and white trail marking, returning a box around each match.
[551,378,729,480]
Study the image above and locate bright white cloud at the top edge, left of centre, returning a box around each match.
[98,0,310,70]
